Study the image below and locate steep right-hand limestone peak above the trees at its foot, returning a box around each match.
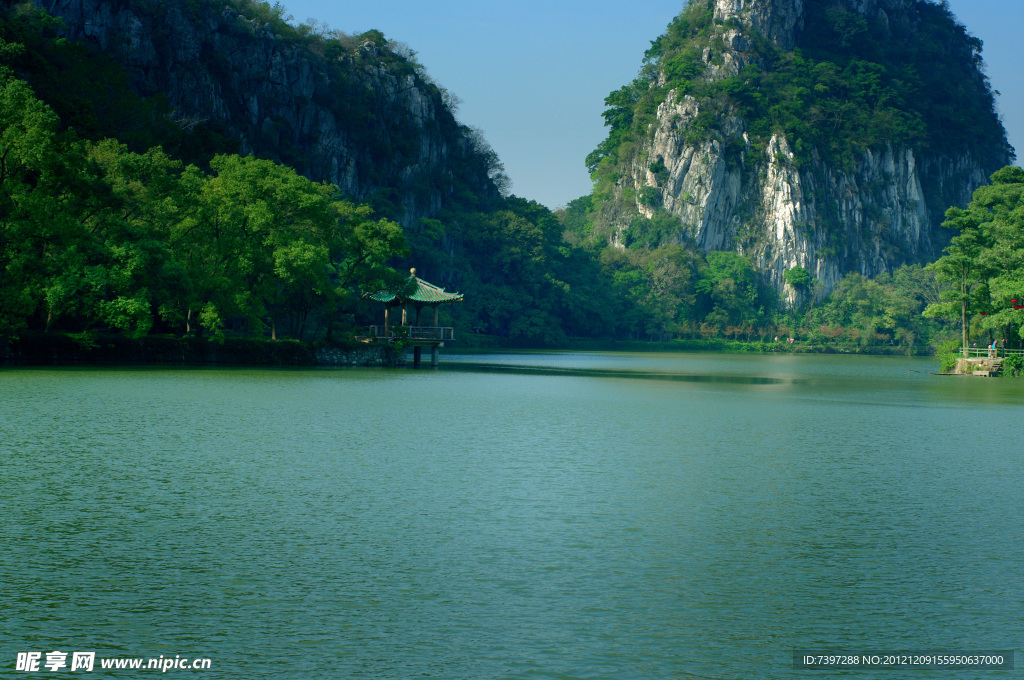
[573,0,1013,305]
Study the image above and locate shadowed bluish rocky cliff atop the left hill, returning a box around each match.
[39,0,497,227]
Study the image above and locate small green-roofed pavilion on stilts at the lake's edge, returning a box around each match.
[361,268,462,369]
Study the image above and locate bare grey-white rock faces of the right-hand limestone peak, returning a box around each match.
[621,0,1010,303]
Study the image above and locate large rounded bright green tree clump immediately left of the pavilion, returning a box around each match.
[171,156,406,337]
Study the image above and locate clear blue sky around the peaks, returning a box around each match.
[282,0,1024,208]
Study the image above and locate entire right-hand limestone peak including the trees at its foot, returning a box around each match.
[544,0,1014,348]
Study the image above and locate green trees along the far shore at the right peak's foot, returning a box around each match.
[560,191,952,353]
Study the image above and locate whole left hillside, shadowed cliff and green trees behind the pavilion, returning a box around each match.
[0,1,616,342]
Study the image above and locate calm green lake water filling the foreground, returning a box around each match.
[0,353,1024,680]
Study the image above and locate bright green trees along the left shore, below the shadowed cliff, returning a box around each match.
[0,73,404,338]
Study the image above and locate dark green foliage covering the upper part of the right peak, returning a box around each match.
[587,0,1013,179]
